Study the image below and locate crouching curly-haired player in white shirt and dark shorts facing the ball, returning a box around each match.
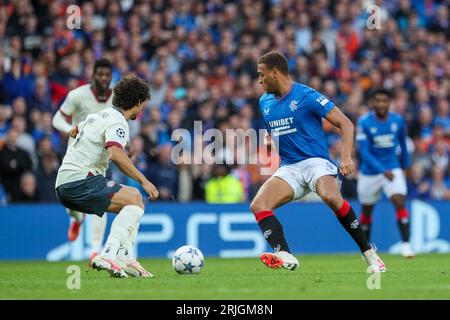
[56,76,158,277]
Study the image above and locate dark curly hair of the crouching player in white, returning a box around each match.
[113,75,151,110]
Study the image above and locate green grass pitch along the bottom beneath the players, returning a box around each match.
[0,254,450,300]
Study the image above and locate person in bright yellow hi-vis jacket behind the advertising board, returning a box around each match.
[205,164,245,203]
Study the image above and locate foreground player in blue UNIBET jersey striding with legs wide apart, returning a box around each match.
[250,51,386,272]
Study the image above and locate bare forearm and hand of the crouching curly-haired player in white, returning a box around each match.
[108,146,159,200]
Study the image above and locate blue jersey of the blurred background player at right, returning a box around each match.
[356,112,411,175]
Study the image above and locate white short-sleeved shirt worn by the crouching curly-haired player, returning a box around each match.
[55,108,129,187]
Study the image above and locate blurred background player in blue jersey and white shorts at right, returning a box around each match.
[356,89,414,258]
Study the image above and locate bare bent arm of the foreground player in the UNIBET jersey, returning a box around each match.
[325,106,355,176]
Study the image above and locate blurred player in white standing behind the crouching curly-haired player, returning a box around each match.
[53,59,113,254]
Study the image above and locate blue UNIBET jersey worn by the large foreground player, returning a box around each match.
[259,82,334,166]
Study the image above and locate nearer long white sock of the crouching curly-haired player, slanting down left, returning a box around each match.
[101,205,144,259]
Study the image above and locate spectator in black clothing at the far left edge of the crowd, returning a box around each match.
[0,129,32,199]
